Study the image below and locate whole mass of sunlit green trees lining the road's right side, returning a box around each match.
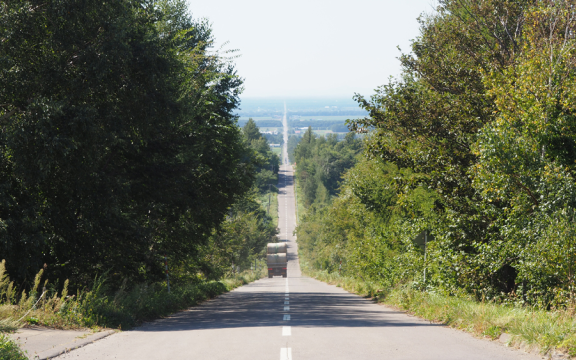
[295,0,576,308]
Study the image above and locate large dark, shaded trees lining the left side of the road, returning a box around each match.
[0,0,254,283]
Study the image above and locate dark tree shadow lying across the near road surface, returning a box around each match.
[133,279,442,331]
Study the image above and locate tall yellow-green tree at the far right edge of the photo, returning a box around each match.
[472,1,576,304]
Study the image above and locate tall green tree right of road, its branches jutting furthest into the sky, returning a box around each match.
[350,0,535,296]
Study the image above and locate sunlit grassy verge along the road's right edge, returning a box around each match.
[302,260,576,356]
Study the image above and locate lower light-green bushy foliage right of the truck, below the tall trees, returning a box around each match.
[297,159,435,287]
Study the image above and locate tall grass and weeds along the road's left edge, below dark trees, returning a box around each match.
[0,261,266,332]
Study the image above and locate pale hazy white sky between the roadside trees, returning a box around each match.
[188,0,436,98]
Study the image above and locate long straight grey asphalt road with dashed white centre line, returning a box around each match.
[54,108,540,360]
